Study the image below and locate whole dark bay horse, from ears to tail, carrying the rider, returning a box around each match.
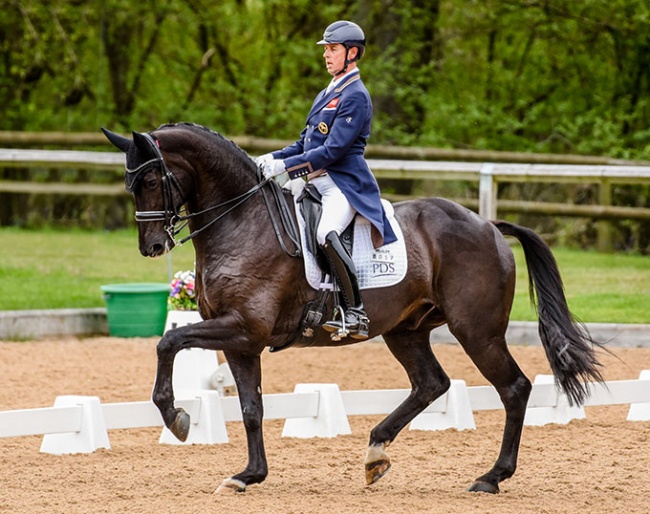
[104,123,602,493]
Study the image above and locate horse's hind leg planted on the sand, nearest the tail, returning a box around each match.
[450,325,532,493]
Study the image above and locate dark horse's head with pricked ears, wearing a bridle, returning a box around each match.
[102,128,184,257]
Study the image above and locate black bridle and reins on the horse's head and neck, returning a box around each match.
[125,132,301,257]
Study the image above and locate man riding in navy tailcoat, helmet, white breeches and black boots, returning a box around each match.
[256,20,397,339]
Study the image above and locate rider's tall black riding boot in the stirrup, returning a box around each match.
[321,231,370,339]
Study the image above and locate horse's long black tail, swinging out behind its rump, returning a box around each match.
[493,221,603,405]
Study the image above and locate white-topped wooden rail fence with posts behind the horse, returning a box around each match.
[0,149,650,250]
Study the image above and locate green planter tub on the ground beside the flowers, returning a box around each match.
[100,283,170,337]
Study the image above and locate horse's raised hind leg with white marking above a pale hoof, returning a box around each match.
[365,330,450,484]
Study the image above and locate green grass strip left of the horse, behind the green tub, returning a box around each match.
[0,229,194,310]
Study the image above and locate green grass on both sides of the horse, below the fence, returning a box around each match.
[0,228,650,323]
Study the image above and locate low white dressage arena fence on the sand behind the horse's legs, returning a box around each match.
[0,370,650,455]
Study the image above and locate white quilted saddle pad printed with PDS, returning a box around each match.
[291,180,408,289]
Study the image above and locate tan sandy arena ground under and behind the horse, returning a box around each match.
[0,338,650,514]
